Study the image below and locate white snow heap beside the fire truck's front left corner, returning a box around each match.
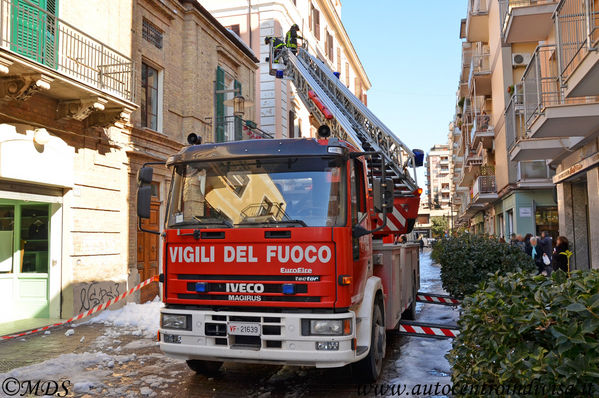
[85,296,163,337]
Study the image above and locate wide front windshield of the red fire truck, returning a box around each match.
[168,158,346,228]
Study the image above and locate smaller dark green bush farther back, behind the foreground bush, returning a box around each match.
[432,234,536,298]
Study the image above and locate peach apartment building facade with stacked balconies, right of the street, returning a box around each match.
[456,0,599,269]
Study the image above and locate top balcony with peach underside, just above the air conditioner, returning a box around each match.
[499,0,558,44]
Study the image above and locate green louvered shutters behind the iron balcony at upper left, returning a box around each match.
[11,0,58,69]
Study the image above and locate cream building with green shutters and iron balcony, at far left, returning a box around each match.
[0,0,137,322]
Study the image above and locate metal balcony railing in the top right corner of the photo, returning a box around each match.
[556,0,599,80]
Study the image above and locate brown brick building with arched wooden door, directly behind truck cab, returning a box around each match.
[128,0,258,301]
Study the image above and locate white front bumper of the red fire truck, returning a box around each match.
[160,308,360,368]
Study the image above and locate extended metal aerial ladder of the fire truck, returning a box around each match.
[269,42,424,233]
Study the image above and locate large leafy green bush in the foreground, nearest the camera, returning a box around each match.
[447,270,599,397]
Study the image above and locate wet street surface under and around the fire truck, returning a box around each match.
[0,250,457,398]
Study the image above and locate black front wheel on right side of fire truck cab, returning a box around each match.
[355,299,387,383]
